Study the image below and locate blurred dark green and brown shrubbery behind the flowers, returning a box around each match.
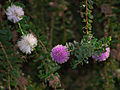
[0,0,120,90]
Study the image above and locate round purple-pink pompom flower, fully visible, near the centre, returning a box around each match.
[51,45,70,64]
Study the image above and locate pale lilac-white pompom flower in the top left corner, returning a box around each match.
[6,5,24,23]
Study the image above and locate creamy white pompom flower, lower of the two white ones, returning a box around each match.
[17,34,37,54]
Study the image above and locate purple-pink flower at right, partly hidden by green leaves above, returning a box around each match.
[92,47,110,61]
